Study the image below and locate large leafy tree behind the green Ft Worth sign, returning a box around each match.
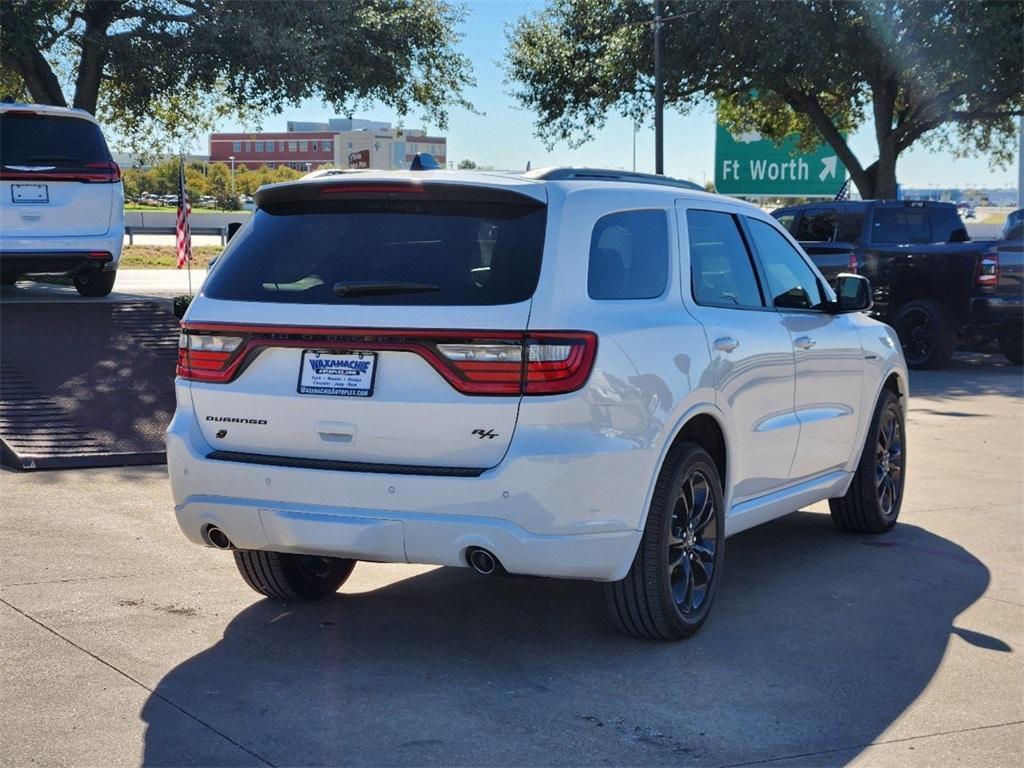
[507,0,1024,198]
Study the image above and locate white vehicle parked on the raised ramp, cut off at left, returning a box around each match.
[0,103,125,296]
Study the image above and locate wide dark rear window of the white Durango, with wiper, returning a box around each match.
[203,200,546,306]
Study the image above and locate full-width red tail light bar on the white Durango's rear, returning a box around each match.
[177,324,597,395]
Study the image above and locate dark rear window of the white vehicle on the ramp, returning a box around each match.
[0,112,111,168]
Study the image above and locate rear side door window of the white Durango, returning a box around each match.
[686,211,764,307]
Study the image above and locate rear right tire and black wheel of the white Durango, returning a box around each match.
[604,442,725,640]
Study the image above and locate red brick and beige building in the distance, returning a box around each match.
[210,118,447,171]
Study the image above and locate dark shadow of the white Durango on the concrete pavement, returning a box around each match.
[142,512,995,766]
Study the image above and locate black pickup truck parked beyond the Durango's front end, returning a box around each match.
[772,200,1024,369]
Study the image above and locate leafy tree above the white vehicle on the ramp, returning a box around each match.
[0,0,472,157]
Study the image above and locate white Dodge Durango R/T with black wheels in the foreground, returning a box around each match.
[167,169,907,639]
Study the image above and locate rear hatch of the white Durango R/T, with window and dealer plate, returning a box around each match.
[179,180,579,473]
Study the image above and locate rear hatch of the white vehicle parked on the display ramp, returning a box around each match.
[0,110,121,238]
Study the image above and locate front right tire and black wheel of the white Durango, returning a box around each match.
[828,389,906,534]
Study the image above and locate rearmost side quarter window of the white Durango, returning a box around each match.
[587,211,669,299]
